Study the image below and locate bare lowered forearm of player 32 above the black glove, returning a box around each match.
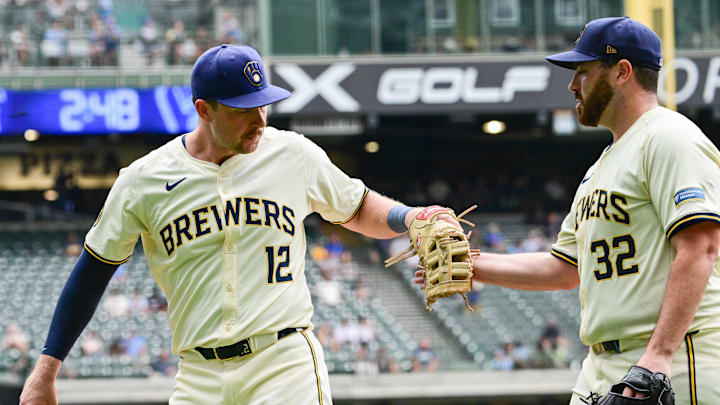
[647,248,717,356]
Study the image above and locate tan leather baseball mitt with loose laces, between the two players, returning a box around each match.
[385,205,477,311]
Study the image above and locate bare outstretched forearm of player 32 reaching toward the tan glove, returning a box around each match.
[473,253,580,290]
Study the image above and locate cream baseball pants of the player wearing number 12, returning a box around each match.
[169,330,332,405]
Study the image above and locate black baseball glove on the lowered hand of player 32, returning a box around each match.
[592,366,675,405]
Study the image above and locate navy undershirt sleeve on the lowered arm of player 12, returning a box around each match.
[42,250,118,360]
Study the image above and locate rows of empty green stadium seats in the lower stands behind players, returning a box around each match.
[0,220,586,377]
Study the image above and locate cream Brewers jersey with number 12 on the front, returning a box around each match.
[85,127,367,353]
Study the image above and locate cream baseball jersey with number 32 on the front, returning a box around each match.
[552,107,720,345]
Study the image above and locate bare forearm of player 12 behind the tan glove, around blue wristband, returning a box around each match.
[343,190,421,239]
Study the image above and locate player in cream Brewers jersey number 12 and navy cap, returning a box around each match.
[21,45,444,405]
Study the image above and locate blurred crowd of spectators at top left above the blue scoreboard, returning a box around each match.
[0,0,254,66]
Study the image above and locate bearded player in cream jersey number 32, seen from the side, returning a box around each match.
[420,17,720,405]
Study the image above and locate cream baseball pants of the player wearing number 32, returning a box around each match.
[570,329,720,405]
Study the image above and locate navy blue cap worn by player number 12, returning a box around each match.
[190,44,290,108]
